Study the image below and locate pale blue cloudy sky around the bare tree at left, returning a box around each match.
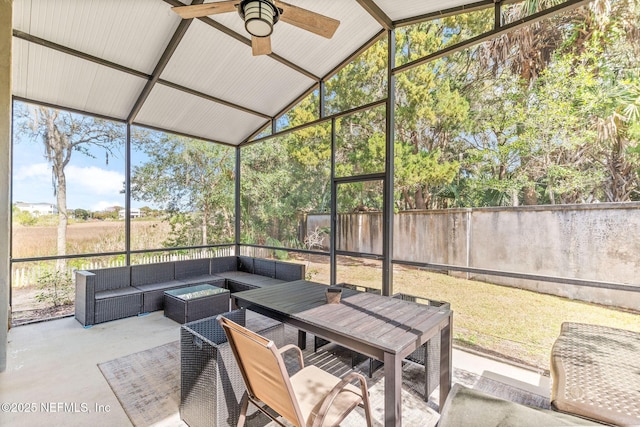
[12,139,146,212]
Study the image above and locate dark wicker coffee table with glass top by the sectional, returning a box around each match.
[164,284,231,324]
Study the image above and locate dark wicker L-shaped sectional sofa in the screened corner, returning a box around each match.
[75,256,305,326]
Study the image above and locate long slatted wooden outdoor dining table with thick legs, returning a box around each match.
[232,280,453,426]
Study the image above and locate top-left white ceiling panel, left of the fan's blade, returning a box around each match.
[13,0,180,74]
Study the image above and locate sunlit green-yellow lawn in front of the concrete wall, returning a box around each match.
[307,262,640,370]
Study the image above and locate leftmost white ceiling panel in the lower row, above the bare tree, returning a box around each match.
[12,38,146,119]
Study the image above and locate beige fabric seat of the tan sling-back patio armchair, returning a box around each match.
[291,365,362,426]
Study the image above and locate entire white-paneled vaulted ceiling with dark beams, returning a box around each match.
[13,0,493,145]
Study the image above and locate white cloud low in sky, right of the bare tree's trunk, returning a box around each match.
[65,165,124,196]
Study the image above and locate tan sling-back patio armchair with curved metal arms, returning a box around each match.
[218,316,372,427]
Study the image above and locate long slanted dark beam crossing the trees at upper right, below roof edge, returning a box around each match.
[393,0,592,74]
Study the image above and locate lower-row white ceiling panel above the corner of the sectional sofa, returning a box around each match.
[136,84,265,145]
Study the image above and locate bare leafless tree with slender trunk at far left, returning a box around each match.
[17,103,125,267]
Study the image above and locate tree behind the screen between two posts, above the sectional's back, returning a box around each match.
[131,132,235,247]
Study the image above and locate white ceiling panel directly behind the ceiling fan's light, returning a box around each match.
[161,20,314,116]
